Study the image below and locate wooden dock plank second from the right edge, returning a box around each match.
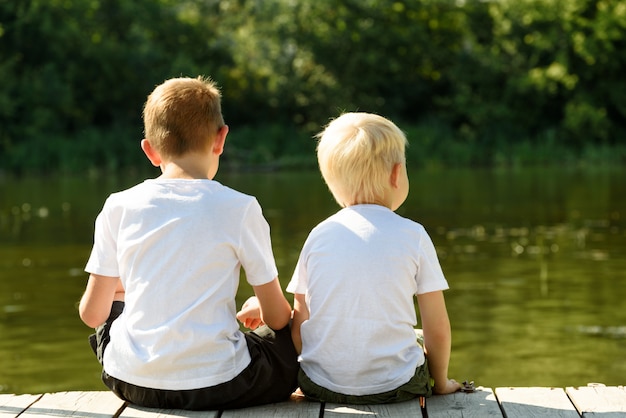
[496,387,580,418]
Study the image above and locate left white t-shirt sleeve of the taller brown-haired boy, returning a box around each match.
[85,203,120,277]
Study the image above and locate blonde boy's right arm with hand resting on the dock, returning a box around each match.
[417,291,461,394]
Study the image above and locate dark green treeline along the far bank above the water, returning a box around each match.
[0,0,626,174]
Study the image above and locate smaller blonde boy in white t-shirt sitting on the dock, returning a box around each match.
[287,113,460,404]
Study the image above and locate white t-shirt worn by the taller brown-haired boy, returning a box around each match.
[85,179,278,390]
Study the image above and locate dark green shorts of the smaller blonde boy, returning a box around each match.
[298,361,432,405]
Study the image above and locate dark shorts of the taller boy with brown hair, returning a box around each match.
[89,302,299,410]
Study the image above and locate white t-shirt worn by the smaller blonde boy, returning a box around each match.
[287,205,448,395]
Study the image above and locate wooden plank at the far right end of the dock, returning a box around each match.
[566,385,626,418]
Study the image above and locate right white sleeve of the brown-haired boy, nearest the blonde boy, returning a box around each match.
[238,199,278,286]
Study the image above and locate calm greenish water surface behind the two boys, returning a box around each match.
[0,169,626,393]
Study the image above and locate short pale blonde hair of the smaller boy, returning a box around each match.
[317,113,408,207]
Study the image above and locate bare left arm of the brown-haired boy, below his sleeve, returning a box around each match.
[78,274,124,328]
